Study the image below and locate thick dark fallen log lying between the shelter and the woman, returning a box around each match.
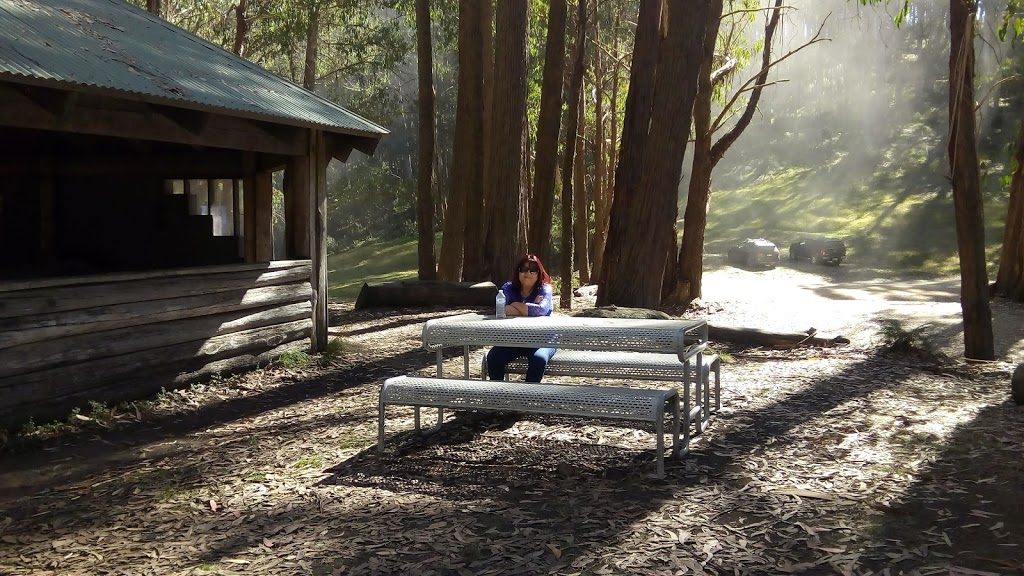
[354,280,498,314]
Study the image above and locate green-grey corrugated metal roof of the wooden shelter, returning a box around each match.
[0,0,387,137]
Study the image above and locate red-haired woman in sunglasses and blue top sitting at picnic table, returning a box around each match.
[487,254,555,382]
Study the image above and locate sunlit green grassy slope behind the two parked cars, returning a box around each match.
[704,145,1007,275]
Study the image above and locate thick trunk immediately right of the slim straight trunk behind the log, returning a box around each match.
[437,0,483,281]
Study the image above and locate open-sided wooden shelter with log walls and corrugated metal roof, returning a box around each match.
[0,0,387,428]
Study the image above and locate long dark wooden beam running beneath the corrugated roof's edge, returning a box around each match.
[0,83,305,156]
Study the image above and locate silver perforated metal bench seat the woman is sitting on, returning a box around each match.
[480,349,722,434]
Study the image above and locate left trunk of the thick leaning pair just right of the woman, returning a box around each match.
[597,0,665,306]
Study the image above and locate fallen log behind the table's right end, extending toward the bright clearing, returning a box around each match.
[573,305,850,348]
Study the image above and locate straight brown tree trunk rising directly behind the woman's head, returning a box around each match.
[528,0,567,261]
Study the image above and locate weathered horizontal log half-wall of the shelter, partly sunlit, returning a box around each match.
[0,260,312,428]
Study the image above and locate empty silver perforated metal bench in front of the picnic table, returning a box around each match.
[377,373,685,478]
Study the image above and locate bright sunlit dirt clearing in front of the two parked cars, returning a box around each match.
[703,260,1024,362]
